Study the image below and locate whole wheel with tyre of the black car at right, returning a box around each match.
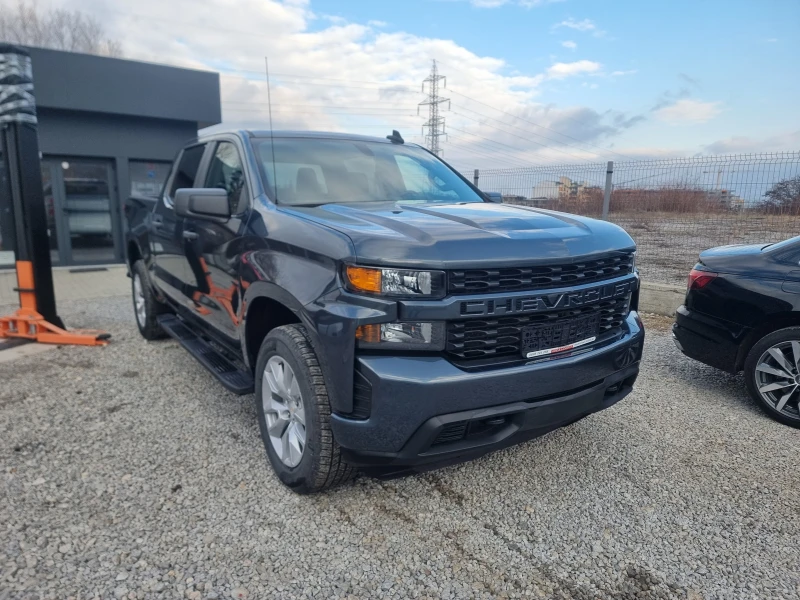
[744,327,800,428]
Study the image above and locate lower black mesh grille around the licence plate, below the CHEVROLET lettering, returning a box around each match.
[445,296,630,361]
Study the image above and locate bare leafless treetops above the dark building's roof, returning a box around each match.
[0,0,122,57]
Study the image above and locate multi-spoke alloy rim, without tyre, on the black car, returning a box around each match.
[755,340,800,420]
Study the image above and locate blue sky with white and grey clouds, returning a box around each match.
[59,0,800,169]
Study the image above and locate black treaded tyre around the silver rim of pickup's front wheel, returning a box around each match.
[255,325,356,494]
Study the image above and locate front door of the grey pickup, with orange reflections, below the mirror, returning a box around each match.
[183,137,250,345]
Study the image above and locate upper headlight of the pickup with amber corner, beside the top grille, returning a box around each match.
[345,265,445,298]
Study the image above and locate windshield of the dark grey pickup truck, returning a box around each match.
[253,137,483,206]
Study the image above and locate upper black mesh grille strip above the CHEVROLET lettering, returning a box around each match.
[447,252,633,295]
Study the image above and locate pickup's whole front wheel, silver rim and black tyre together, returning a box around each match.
[255,325,355,494]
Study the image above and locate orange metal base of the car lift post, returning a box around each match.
[0,260,111,346]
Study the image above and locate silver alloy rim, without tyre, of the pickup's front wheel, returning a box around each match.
[261,356,306,467]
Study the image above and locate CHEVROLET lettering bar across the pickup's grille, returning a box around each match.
[461,280,634,316]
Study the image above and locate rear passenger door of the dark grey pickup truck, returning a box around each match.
[149,144,207,305]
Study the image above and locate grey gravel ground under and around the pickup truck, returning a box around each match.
[0,298,800,599]
